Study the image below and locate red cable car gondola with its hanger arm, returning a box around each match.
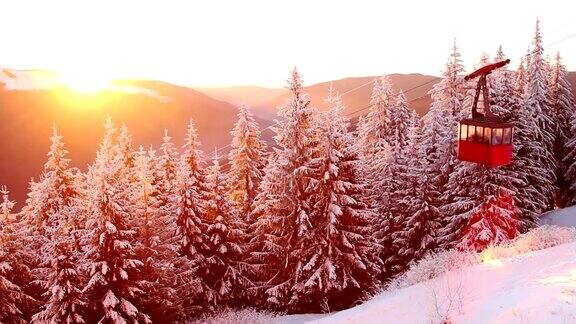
[458,60,514,167]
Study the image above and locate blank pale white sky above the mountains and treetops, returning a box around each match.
[0,0,576,87]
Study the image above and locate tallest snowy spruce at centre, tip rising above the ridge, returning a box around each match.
[250,69,320,312]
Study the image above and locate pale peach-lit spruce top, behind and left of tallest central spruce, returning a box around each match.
[228,105,266,221]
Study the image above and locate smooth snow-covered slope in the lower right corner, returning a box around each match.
[280,229,576,324]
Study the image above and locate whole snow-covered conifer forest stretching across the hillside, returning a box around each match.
[0,19,576,323]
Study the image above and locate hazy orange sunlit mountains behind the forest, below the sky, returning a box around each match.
[0,69,576,208]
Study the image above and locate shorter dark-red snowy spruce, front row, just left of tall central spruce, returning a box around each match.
[202,153,253,307]
